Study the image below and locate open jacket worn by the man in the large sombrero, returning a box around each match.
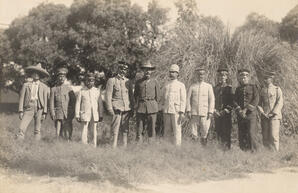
[19,82,49,114]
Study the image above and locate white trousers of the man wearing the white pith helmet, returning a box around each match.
[163,113,182,146]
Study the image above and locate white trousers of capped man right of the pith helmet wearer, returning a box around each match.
[190,115,211,139]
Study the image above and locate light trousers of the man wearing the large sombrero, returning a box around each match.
[18,100,43,140]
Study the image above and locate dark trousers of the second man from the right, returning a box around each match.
[238,115,258,151]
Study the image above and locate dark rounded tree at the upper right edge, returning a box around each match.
[280,5,298,45]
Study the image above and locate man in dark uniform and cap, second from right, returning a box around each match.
[234,69,259,151]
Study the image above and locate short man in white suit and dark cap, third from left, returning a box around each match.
[75,73,103,147]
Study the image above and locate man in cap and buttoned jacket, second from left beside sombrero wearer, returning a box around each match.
[50,68,76,140]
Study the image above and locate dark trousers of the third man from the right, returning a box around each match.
[215,114,232,149]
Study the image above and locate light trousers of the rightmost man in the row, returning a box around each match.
[261,118,280,151]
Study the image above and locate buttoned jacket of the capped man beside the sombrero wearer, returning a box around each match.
[50,85,76,119]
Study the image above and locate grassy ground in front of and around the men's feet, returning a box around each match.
[0,113,298,187]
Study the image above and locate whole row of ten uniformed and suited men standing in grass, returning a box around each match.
[17,61,283,151]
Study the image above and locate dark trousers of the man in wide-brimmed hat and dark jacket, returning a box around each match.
[137,113,157,141]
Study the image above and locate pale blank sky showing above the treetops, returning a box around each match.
[0,0,298,30]
